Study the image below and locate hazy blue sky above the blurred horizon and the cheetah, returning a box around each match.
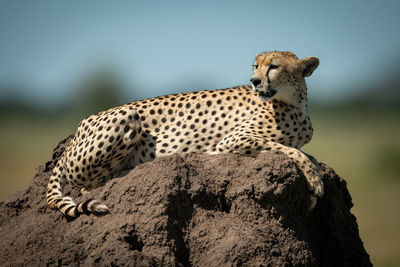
[0,0,400,105]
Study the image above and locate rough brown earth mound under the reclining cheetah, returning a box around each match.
[0,137,371,266]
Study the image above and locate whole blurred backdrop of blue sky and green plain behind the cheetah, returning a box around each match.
[0,1,400,266]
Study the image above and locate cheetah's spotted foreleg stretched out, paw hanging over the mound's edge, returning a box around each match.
[217,135,324,210]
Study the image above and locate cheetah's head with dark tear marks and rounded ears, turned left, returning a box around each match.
[250,51,319,104]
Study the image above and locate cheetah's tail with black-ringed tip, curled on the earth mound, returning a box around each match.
[46,165,109,219]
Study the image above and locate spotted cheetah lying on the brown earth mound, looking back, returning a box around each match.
[46,51,324,218]
